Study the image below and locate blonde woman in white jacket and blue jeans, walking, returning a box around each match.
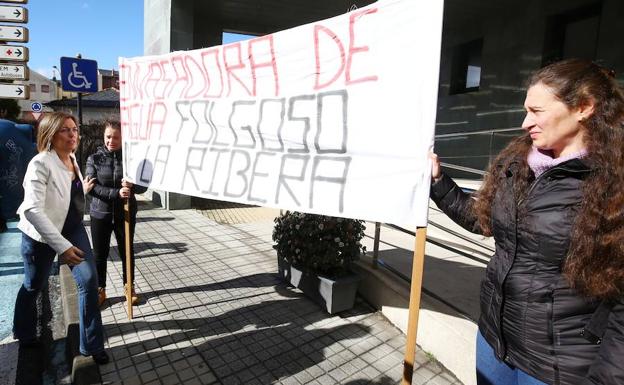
[13,112,108,364]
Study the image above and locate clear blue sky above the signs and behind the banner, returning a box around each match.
[23,0,254,78]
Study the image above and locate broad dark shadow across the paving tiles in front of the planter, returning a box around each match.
[101,274,376,384]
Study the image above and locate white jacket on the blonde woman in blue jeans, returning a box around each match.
[17,150,84,254]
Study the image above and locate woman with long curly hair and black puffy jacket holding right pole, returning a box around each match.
[431,59,624,385]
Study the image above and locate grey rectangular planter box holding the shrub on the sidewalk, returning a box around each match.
[277,257,362,314]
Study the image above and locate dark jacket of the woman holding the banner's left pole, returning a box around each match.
[86,146,147,219]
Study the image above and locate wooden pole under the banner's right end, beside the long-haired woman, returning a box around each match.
[401,227,427,385]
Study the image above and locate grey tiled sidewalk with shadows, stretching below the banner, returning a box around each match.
[95,202,460,385]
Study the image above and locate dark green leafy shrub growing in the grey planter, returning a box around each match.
[273,211,366,278]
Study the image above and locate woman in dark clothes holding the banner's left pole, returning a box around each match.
[87,121,147,305]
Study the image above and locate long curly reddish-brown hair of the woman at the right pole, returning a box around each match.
[474,59,624,298]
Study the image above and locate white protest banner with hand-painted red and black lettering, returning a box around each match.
[120,0,443,226]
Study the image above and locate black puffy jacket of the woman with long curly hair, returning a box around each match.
[431,159,624,385]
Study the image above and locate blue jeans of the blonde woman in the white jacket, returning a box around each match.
[13,224,104,355]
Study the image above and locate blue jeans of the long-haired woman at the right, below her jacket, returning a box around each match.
[477,332,546,385]
